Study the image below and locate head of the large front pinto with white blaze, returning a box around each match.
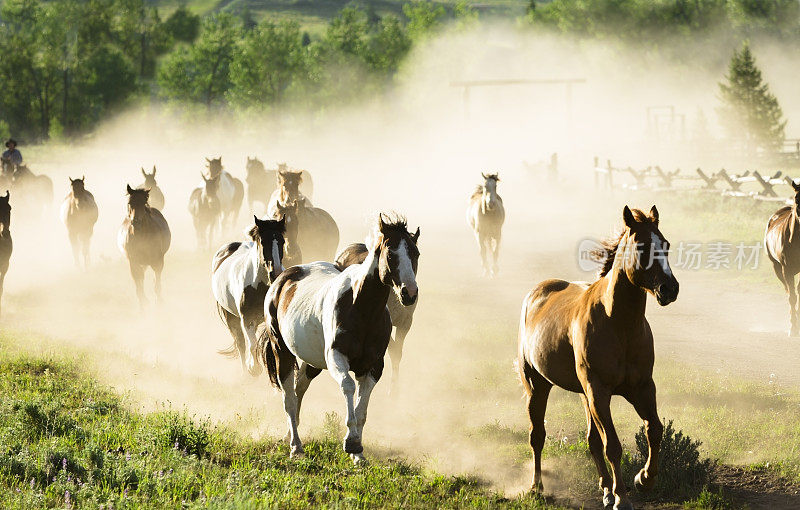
[373,213,420,306]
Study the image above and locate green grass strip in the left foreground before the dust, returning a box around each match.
[0,340,564,508]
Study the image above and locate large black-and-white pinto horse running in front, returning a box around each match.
[259,216,419,463]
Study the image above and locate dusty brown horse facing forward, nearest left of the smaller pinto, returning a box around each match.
[117,185,172,307]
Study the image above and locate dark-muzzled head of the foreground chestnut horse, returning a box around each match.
[606,206,679,306]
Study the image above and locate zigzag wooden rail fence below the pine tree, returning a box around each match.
[594,157,797,205]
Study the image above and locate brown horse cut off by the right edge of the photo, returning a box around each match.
[764,181,800,336]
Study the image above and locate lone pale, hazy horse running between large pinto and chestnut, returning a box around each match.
[467,173,506,276]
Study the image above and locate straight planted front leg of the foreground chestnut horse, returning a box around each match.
[585,382,633,510]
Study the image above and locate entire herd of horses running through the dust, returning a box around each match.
[0,158,800,509]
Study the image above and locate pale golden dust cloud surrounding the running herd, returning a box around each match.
[2,21,800,493]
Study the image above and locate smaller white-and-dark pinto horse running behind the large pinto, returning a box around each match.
[211,216,286,375]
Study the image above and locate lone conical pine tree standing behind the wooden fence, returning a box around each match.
[718,42,786,152]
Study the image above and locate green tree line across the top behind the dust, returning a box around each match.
[0,0,800,151]
